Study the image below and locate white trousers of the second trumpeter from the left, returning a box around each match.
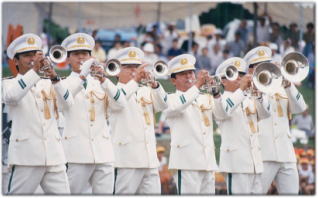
[67,163,114,194]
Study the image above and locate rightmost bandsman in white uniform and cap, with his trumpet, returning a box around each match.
[244,46,308,195]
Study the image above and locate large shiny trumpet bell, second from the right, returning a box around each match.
[253,63,283,94]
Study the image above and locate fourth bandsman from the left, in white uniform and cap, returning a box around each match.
[165,54,218,195]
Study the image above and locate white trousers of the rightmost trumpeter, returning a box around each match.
[262,161,299,195]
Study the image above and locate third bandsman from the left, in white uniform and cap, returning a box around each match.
[110,47,167,194]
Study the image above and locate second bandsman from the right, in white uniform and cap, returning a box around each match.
[216,57,270,194]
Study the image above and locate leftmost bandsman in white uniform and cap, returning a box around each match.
[2,34,73,194]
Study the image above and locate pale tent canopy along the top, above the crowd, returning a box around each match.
[2,2,314,35]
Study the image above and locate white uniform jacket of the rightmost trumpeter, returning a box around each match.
[259,84,307,162]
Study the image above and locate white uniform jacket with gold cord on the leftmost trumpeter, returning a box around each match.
[2,69,73,166]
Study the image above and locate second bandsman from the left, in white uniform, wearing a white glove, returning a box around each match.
[60,33,126,194]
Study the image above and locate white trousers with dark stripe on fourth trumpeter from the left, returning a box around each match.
[174,170,215,195]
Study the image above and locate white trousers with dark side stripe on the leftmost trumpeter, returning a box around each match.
[8,164,70,195]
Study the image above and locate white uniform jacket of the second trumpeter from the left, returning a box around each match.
[62,72,126,163]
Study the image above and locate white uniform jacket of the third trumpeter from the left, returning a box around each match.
[110,80,167,168]
